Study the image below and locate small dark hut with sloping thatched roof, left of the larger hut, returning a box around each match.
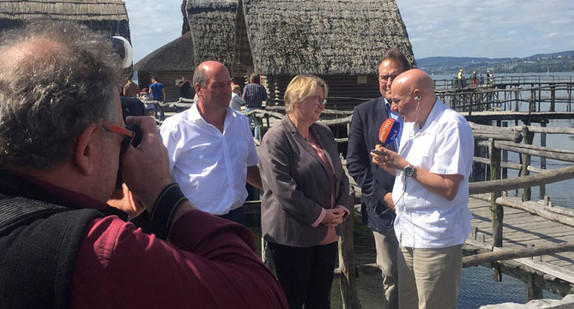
[134,32,194,102]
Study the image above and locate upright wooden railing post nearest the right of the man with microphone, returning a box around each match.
[488,138,504,281]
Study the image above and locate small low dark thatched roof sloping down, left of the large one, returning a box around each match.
[134,32,195,72]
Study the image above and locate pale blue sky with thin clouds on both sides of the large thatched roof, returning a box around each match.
[124,0,574,63]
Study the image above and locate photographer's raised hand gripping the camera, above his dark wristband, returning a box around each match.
[121,117,172,211]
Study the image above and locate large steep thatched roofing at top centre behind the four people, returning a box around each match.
[187,0,414,76]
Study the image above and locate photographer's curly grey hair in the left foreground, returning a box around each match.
[0,21,121,170]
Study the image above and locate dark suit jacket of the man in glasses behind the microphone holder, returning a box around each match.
[347,97,395,233]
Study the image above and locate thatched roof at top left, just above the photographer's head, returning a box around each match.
[0,0,130,40]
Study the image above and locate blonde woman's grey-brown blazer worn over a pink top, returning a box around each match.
[259,116,349,247]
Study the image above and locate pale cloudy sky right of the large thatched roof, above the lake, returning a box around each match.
[396,0,574,58]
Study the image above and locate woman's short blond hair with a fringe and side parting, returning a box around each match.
[284,75,329,113]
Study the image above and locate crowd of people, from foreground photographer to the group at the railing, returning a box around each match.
[0,21,474,309]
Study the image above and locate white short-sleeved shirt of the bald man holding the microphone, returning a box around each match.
[393,99,474,248]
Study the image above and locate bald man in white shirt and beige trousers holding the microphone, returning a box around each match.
[372,69,474,309]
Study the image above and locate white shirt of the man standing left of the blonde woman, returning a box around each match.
[160,104,259,215]
